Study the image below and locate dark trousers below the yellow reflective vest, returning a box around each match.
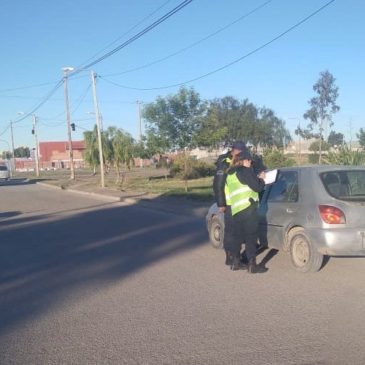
[224,204,259,261]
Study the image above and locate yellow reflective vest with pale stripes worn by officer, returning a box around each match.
[224,172,259,215]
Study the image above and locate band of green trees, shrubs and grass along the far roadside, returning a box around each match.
[7,71,365,200]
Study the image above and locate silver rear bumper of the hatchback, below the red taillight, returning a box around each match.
[308,227,365,256]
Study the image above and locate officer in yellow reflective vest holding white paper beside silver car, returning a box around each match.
[224,148,267,273]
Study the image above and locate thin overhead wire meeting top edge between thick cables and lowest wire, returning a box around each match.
[104,0,273,77]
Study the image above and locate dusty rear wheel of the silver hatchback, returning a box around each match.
[289,228,324,272]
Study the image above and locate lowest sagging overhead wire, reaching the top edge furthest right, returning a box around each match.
[99,0,335,91]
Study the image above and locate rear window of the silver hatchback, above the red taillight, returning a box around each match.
[321,170,365,201]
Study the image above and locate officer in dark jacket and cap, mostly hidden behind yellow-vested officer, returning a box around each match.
[213,141,247,265]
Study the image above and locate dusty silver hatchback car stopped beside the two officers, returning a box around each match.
[206,165,365,272]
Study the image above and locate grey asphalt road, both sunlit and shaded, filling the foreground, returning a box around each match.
[0,182,365,365]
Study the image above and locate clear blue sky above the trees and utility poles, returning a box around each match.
[0,0,365,151]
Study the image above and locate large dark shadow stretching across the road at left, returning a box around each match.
[0,193,208,334]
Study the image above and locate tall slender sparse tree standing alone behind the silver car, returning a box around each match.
[297,70,340,163]
